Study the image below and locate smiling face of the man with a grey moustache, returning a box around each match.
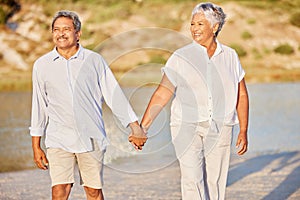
[52,17,81,50]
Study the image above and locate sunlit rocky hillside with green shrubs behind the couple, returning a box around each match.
[0,0,300,90]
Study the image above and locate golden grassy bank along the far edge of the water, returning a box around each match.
[0,67,300,92]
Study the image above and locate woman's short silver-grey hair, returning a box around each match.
[192,3,226,36]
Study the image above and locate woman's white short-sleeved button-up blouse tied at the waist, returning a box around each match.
[162,41,245,125]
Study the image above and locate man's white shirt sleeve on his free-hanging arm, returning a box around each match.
[29,65,48,136]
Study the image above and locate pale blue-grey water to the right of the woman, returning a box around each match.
[249,83,300,152]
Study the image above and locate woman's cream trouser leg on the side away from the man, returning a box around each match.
[205,126,232,200]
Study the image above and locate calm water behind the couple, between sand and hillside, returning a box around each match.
[0,83,300,172]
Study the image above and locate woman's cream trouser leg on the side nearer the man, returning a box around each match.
[171,124,208,200]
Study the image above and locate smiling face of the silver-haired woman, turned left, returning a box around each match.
[190,12,216,46]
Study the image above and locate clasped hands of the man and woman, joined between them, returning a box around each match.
[128,123,148,150]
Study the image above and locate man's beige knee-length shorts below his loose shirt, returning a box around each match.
[47,140,104,189]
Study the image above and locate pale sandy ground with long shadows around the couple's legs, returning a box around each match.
[0,151,300,200]
